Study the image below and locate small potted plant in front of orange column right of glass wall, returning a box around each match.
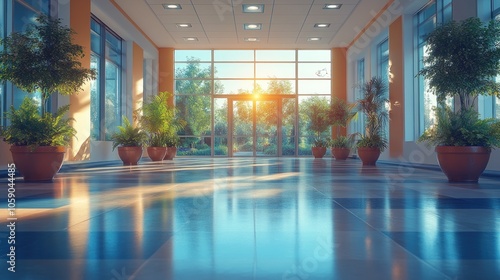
[330,98,357,160]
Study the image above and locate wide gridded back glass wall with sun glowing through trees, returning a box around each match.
[175,50,331,156]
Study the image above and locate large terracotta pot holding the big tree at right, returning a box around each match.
[436,146,491,182]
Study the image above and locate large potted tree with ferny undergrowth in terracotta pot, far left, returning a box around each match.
[0,15,96,181]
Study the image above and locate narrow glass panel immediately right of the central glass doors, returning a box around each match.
[281,98,297,156]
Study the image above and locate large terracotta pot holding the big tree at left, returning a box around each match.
[10,146,66,182]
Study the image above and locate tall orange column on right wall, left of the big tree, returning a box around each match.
[389,17,405,158]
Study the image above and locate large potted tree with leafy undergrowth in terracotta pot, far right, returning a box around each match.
[419,17,500,182]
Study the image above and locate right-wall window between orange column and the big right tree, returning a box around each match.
[415,0,452,135]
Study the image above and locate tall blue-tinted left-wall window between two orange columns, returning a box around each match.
[90,18,123,140]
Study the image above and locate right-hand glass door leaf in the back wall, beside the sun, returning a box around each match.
[255,100,278,156]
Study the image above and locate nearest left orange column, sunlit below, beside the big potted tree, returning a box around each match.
[67,0,91,161]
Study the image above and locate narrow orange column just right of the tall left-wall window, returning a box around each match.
[132,42,144,123]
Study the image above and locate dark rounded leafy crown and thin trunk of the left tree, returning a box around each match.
[0,14,96,115]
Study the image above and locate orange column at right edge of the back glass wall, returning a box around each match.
[331,48,347,137]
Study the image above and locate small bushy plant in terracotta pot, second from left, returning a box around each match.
[111,116,148,165]
